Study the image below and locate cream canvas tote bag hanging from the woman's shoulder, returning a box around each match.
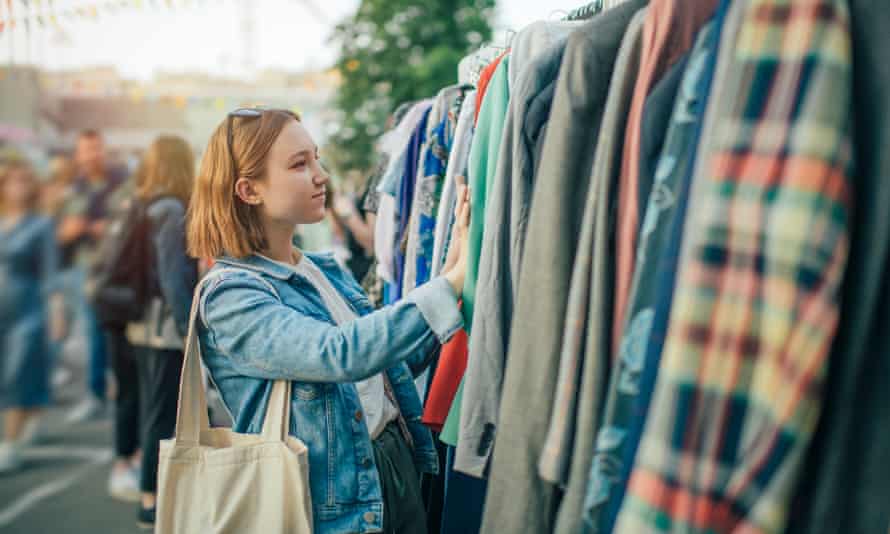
[155,271,312,534]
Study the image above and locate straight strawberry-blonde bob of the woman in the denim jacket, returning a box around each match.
[186,109,300,258]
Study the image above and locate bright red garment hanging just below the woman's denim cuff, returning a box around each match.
[421,329,470,432]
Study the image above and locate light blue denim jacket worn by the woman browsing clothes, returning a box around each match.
[198,253,462,534]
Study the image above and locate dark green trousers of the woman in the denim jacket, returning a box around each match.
[372,423,427,534]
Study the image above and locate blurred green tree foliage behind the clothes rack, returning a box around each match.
[326,0,495,178]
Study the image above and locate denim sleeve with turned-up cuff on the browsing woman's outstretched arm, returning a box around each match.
[201,273,462,382]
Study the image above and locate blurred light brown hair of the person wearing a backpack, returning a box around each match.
[136,135,195,206]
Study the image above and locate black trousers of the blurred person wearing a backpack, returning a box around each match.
[139,348,182,493]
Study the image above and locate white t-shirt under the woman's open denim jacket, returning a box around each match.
[266,255,399,439]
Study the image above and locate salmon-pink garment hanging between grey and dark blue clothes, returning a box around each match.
[612,0,717,357]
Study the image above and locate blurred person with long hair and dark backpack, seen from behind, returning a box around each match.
[108,136,198,528]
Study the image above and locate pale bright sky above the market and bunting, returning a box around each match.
[0,0,584,79]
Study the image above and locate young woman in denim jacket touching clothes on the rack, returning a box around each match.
[188,110,469,534]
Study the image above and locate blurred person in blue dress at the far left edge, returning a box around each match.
[0,162,65,473]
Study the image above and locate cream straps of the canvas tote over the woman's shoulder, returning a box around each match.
[175,268,290,445]
